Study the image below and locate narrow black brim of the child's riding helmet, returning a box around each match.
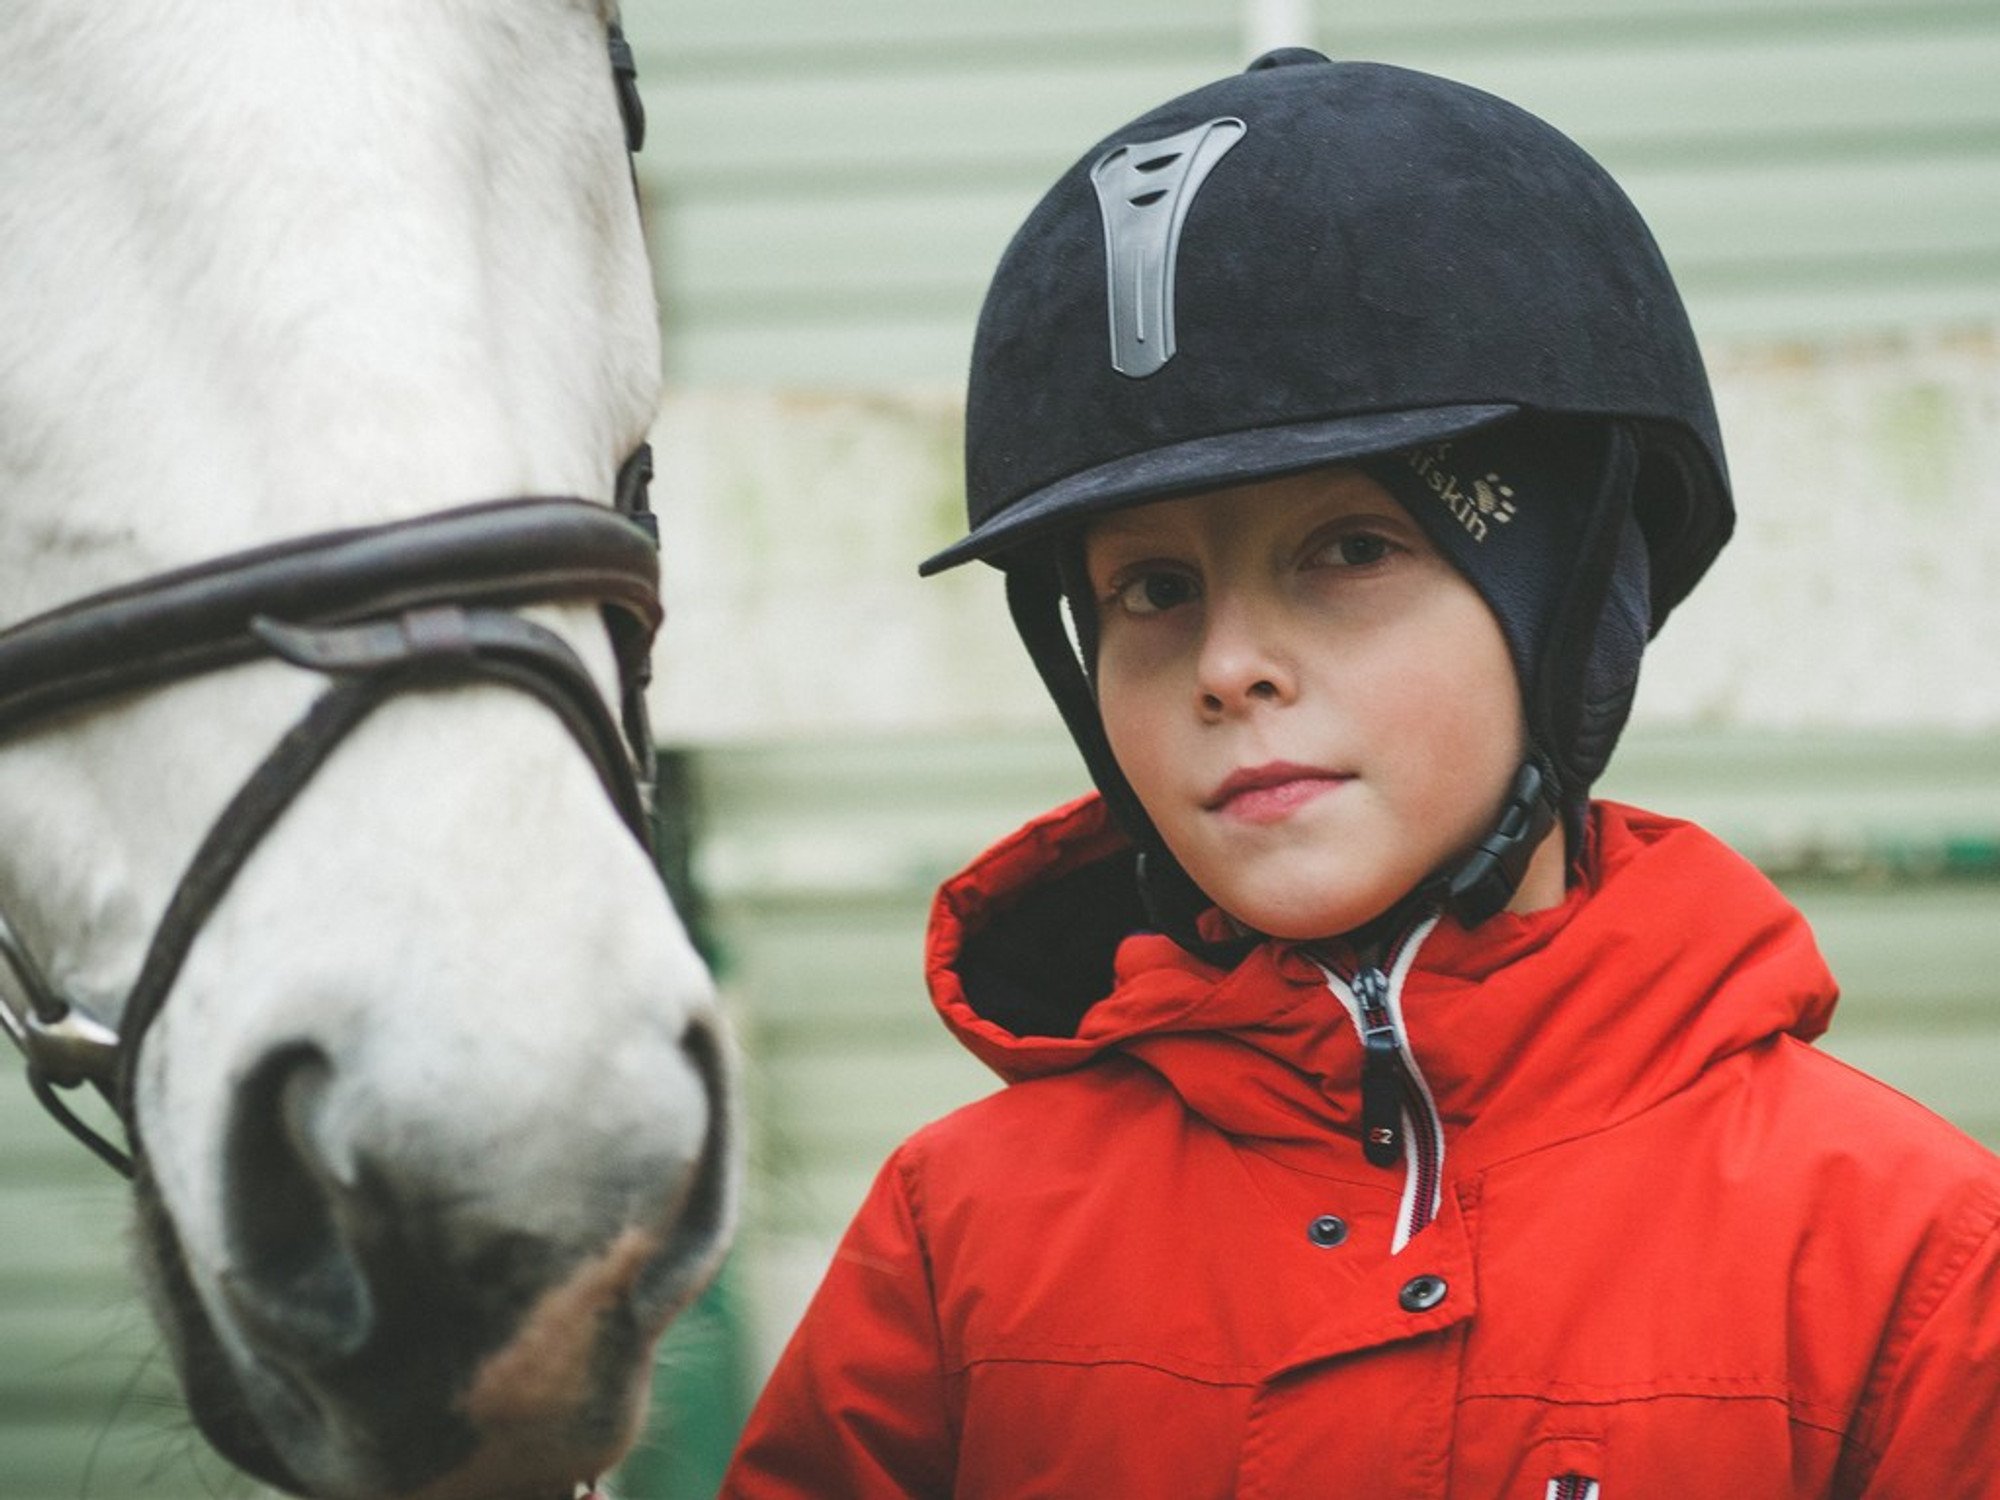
[918,404,1520,578]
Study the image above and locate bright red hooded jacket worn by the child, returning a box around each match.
[722,800,2000,1500]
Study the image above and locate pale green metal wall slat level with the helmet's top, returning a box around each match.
[642,27,2000,197]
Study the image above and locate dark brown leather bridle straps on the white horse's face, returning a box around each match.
[0,26,660,1178]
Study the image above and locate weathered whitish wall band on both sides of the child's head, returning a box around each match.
[654,328,2000,760]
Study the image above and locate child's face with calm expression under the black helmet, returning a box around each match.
[1086,468,1536,938]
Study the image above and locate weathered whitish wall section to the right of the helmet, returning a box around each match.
[1664,326,2000,736]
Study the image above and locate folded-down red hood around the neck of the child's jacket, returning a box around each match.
[928,796,1836,1168]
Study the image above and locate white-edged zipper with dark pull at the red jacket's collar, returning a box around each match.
[1320,918,1444,1252]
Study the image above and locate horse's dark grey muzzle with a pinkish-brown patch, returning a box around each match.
[142,1022,734,1500]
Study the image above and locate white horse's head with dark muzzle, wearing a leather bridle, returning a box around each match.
[0,0,732,1500]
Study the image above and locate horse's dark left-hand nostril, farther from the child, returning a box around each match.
[222,1044,374,1364]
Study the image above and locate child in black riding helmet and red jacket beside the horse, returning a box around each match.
[724,50,2000,1500]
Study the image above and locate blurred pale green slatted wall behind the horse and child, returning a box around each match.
[0,0,2000,1500]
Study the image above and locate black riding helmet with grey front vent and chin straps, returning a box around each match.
[922,48,1734,952]
